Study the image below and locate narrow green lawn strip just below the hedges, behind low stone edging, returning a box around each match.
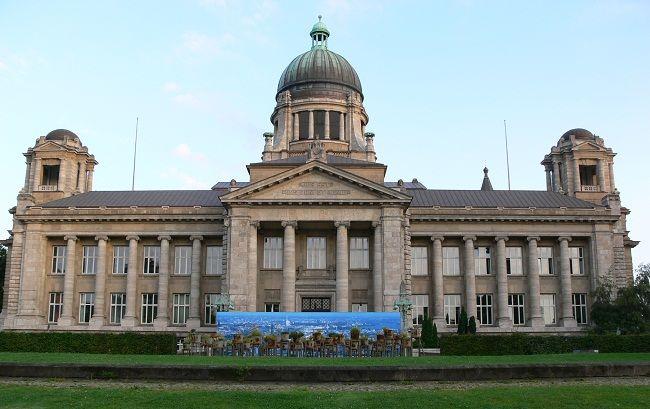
[0,352,650,366]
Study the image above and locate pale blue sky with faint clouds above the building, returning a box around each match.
[0,0,650,263]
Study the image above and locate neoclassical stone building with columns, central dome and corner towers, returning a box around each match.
[0,21,637,333]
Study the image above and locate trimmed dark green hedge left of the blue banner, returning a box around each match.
[0,332,176,355]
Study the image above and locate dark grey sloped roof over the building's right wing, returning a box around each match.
[406,189,596,209]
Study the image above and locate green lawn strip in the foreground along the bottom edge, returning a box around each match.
[0,385,650,409]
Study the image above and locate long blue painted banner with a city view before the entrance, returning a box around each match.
[217,312,401,337]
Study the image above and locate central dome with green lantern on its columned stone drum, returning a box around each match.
[262,16,376,162]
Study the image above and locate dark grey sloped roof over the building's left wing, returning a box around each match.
[41,190,227,208]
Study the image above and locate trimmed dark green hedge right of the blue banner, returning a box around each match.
[440,334,650,355]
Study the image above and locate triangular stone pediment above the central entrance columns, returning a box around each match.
[220,161,411,204]
